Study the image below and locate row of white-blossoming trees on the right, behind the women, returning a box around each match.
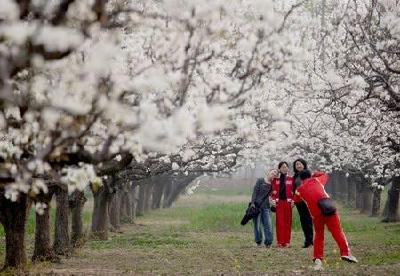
[284,1,400,222]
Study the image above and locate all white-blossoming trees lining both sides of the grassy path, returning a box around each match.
[0,0,400,272]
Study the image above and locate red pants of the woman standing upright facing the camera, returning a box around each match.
[276,200,292,246]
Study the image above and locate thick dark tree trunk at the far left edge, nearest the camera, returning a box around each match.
[0,191,28,269]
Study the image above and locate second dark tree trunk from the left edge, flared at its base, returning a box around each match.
[32,187,60,262]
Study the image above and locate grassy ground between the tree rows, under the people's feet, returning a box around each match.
[0,189,400,275]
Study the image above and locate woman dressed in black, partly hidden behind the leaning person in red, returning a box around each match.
[293,158,314,248]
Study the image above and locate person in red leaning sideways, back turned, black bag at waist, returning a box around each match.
[294,172,357,270]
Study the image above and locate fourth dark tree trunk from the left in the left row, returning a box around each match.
[69,191,86,248]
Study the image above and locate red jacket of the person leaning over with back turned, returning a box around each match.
[294,172,329,218]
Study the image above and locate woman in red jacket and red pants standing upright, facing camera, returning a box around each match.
[271,162,294,247]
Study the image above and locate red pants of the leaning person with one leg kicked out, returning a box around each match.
[313,214,350,259]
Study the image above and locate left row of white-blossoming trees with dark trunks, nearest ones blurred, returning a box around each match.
[0,0,306,268]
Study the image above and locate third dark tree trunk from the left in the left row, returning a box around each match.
[53,186,71,256]
